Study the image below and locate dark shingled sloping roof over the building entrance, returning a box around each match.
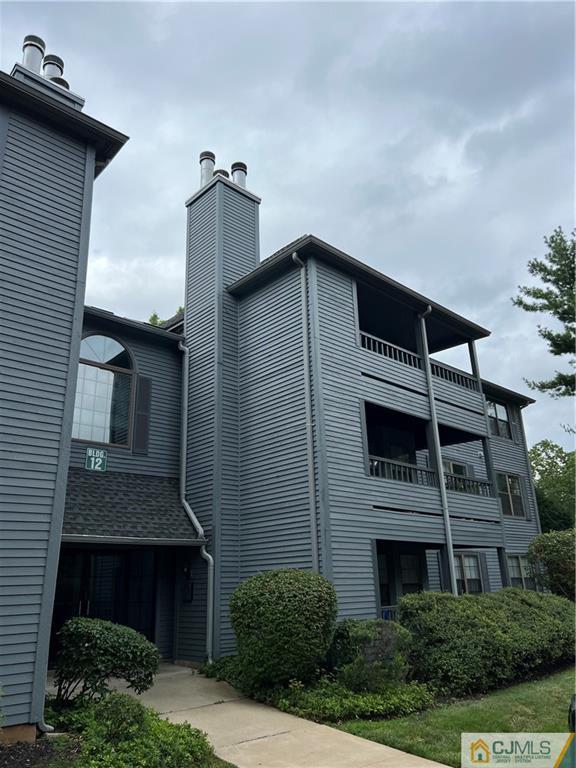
[62,467,199,544]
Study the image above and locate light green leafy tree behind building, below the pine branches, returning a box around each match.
[529,440,576,531]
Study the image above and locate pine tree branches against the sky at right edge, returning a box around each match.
[512,227,576,397]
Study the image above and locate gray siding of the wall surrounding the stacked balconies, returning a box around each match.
[311,262,526,617]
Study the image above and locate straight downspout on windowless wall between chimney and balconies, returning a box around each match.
[292,252,320,573]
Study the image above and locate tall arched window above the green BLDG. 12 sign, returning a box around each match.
[72,335,133,445]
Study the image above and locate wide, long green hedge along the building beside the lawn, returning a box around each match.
[399,589,574,696]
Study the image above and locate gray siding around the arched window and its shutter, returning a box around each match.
[70,320,182,477]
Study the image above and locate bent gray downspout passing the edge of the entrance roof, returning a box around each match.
[178,341,214,663]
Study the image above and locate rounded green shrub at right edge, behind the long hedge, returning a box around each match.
[528,528,576,600]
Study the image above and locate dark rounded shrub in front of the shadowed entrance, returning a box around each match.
[55,618,160,704]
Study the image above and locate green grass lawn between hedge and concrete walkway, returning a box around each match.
[339,669,574,768]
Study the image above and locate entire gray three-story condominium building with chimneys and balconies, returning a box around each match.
[0,38,539,727]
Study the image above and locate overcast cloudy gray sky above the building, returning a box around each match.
[0,2,574,447]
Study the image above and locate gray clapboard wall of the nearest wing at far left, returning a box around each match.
[0,110,94,725]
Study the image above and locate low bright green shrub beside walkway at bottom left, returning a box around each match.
[45,693,214,768]
